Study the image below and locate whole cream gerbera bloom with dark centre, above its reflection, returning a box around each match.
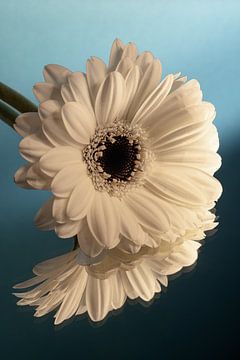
[15,40,222,257]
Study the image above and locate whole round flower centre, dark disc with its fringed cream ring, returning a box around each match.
[83,123,151,197]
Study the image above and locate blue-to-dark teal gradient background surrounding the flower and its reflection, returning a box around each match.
[0,0,240,360]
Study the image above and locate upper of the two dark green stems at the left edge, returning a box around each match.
[0,82,37,113]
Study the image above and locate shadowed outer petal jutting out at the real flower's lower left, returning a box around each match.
[34,198,55,230]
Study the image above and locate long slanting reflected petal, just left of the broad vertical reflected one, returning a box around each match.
[54,267,88,325]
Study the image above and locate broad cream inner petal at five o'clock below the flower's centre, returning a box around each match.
[125,188,170,232]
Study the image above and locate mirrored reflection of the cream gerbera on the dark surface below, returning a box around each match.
[15,214,214,324]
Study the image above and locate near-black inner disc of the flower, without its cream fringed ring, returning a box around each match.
[98,135,139,181]
